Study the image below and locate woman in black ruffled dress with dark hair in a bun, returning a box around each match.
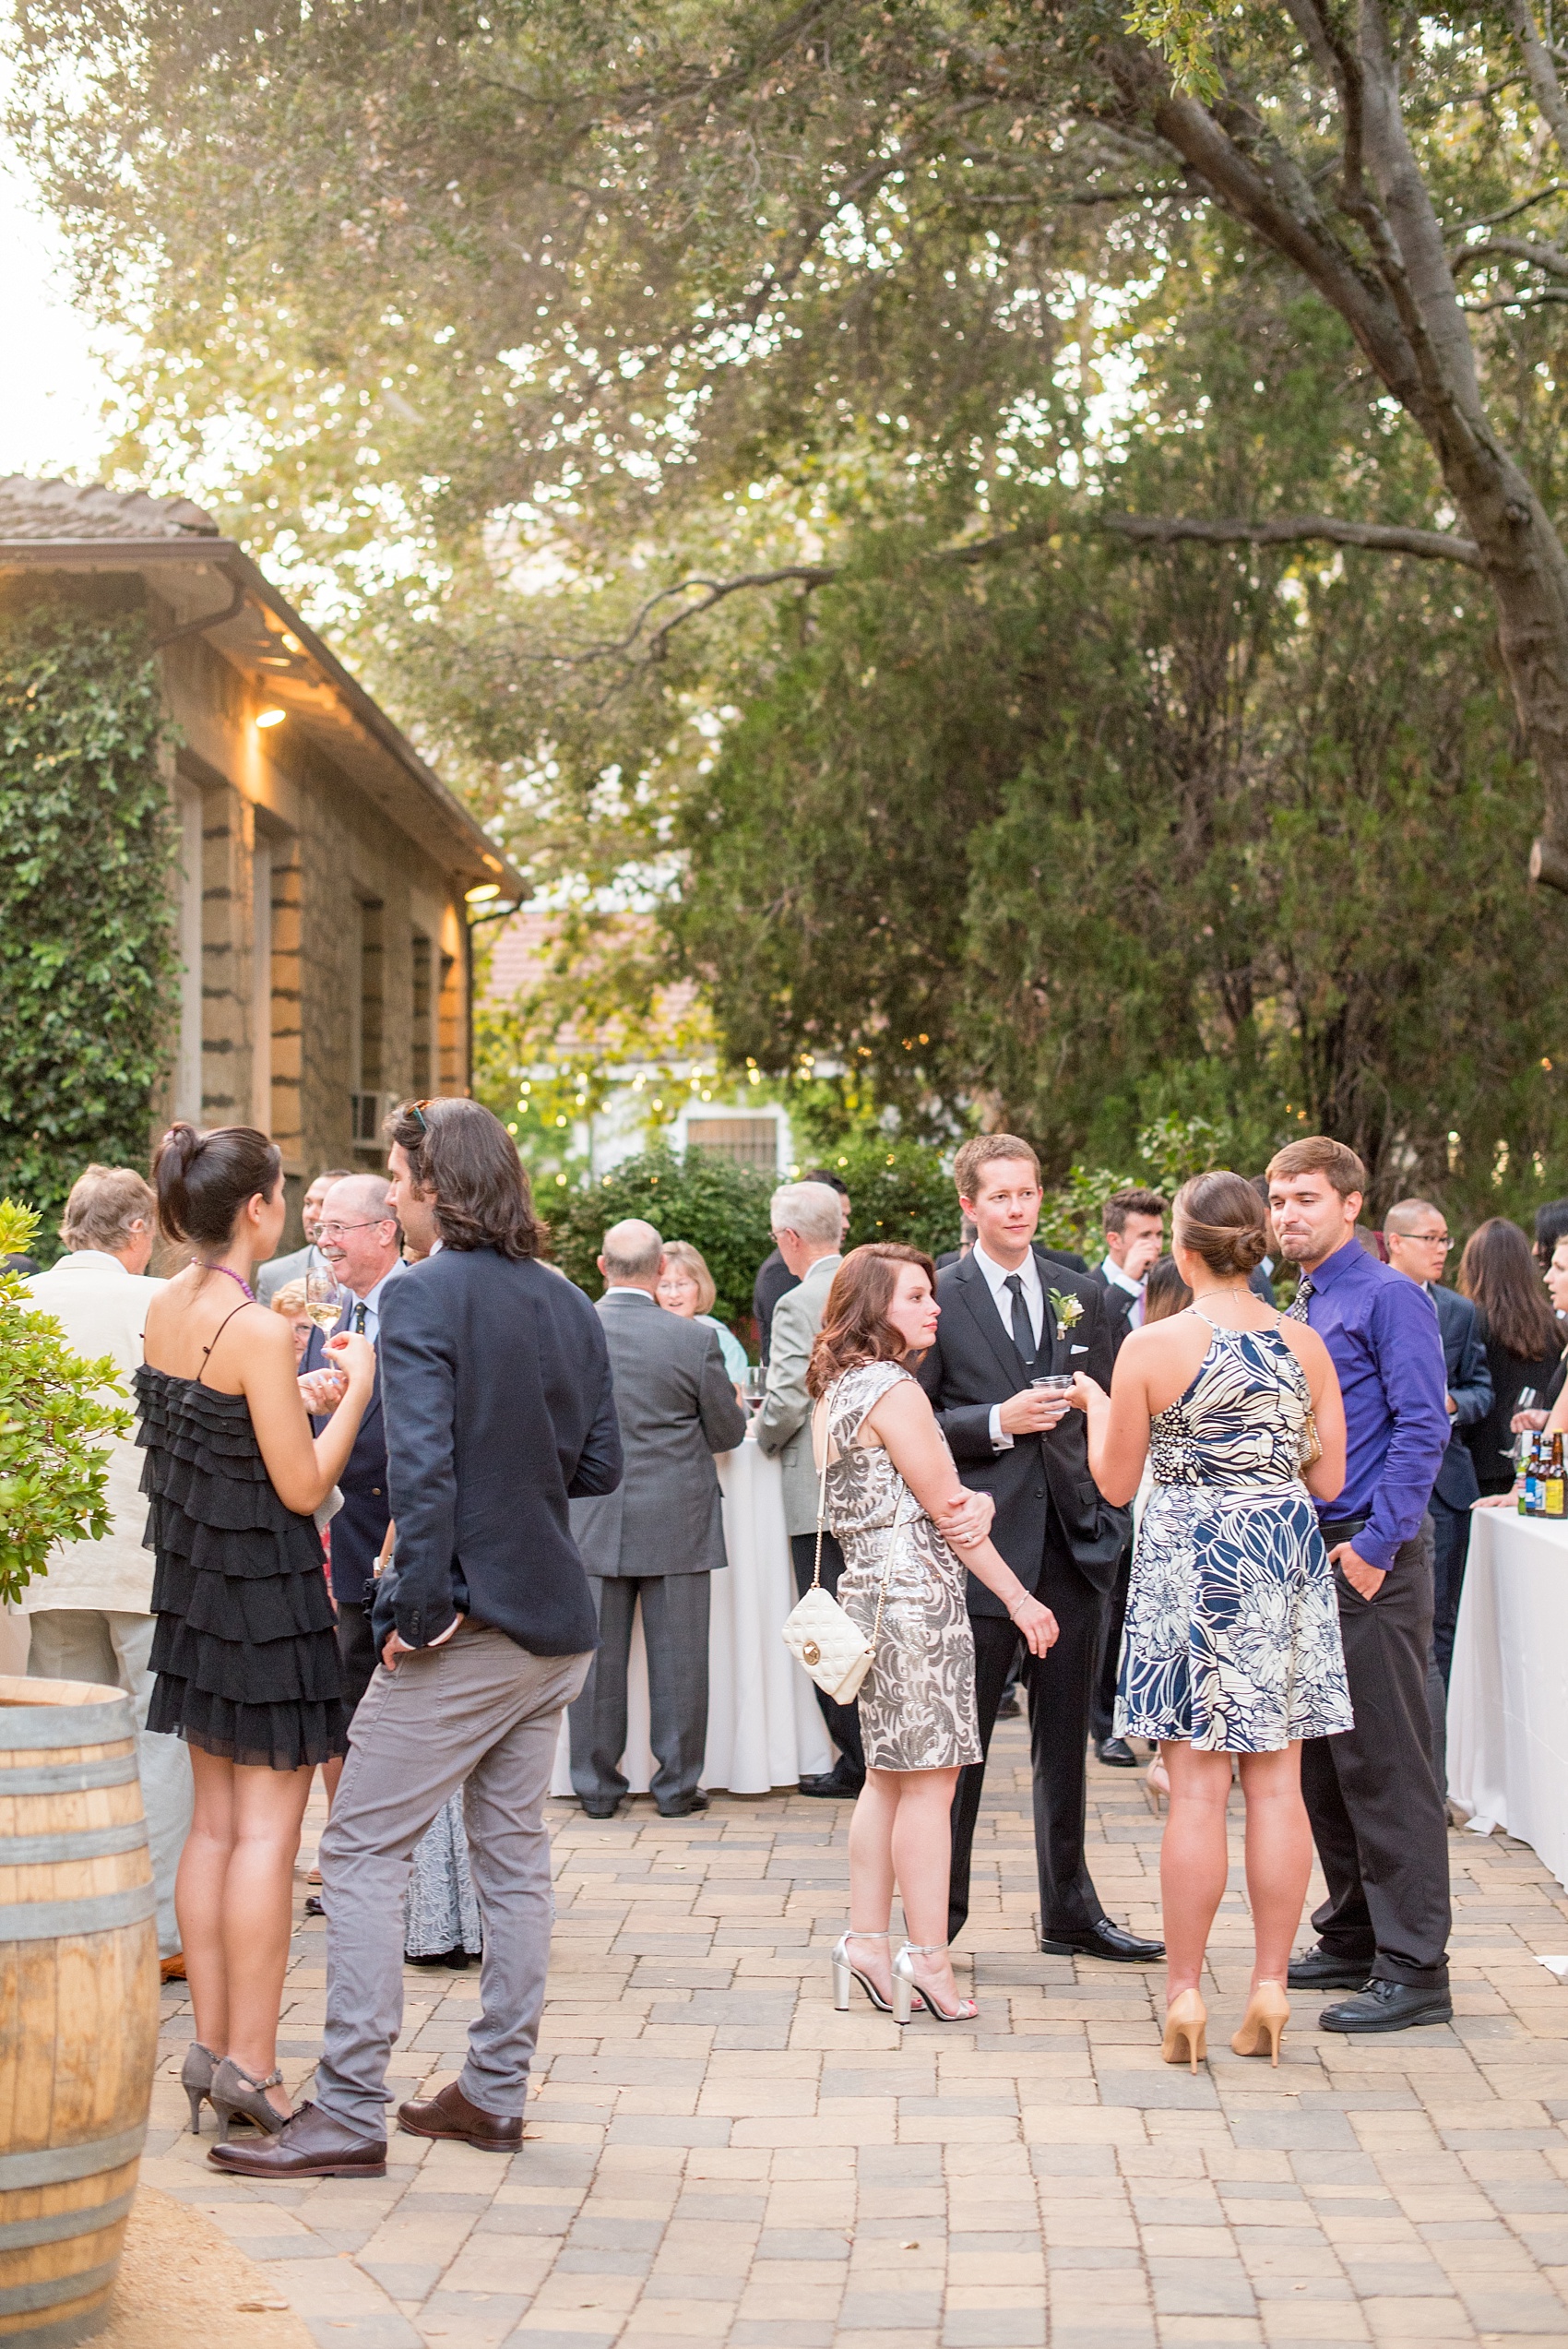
[137,1123,375,2135]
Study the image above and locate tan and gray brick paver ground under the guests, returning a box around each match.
[143,1724,1568,2349]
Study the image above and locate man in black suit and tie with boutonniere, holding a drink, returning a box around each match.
[921,1135,1162,1963]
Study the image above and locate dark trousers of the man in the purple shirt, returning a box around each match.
[1301,1518,1453,1989]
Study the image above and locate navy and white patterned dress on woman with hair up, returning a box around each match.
[1115,1316,1354,1755]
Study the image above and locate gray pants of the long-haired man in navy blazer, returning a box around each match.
[315,1626,589,2138]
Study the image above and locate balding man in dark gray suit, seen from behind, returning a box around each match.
[570,1203,751,1818]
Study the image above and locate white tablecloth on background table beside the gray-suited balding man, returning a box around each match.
[550,1442,833,1795]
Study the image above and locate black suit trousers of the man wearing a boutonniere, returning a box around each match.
[948,1545,1106,1940]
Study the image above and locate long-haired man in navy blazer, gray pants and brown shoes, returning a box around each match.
[216,1100,622,2180]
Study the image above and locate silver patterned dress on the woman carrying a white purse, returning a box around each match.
[826,1363,981,1769]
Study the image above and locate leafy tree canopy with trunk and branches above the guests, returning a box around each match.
[14,0,1568,1182]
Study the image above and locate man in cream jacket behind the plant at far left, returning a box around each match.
[21,1165,193,1980]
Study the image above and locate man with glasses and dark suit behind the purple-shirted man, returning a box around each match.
[1383,1198,1493,1795]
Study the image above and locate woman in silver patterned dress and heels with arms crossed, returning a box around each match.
[805,1243,1056,2022]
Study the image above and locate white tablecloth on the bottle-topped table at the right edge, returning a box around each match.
[1448,1508,1568,1884]
